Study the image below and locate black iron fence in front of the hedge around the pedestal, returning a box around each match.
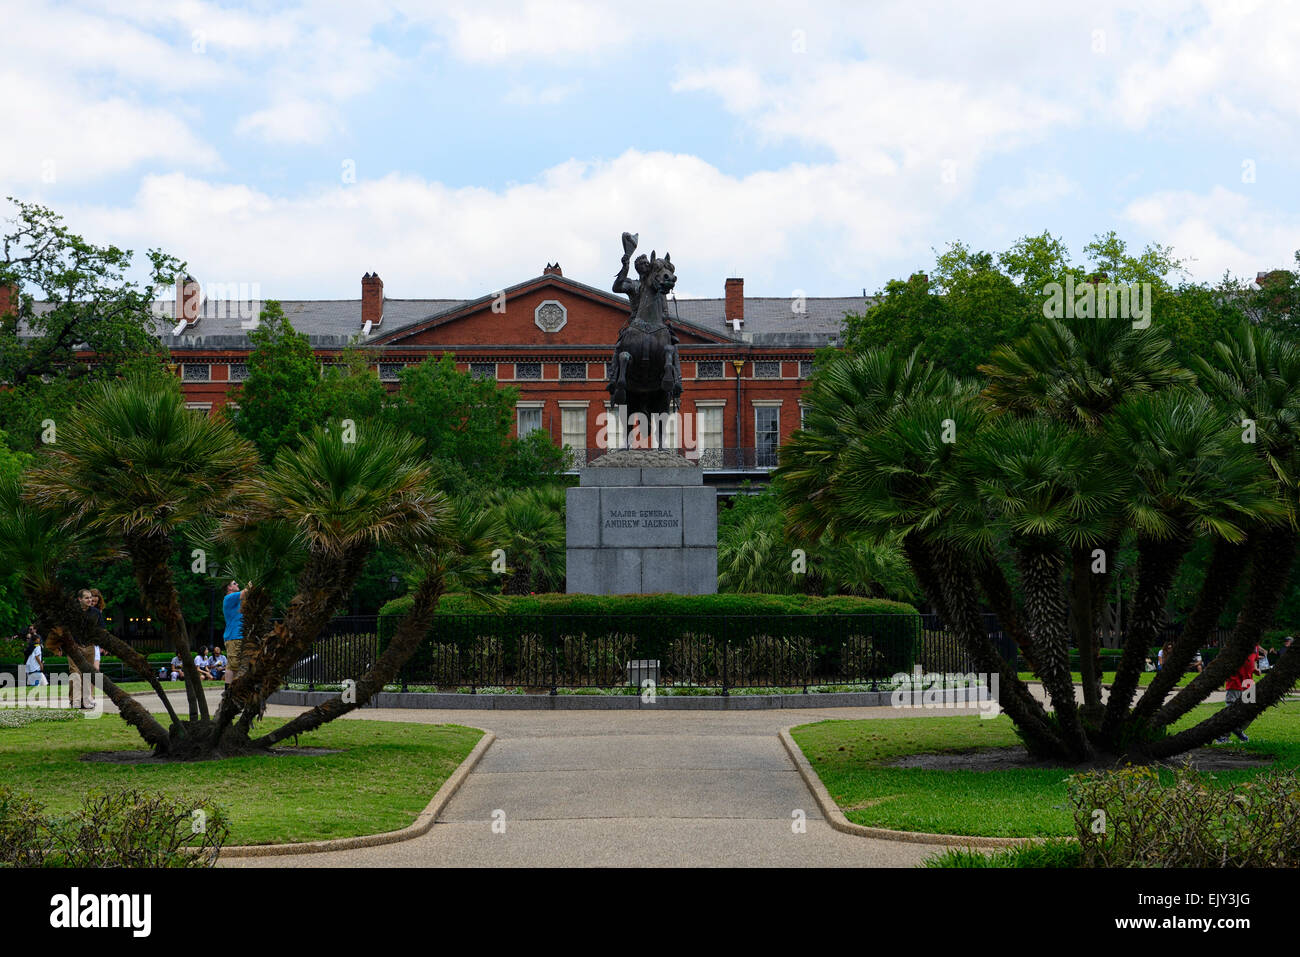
[287,614,1005,694]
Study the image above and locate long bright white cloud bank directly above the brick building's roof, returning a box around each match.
[68,151,932,298]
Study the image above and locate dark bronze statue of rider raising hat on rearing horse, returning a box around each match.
[606,233,681,444]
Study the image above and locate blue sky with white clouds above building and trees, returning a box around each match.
[0,0,1300,299]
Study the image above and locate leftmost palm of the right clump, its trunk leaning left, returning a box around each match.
[776,348,1066,755]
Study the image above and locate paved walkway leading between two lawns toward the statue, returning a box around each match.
[114,694,977,867]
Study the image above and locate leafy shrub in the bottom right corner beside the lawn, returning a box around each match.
[1069,766,1300,867]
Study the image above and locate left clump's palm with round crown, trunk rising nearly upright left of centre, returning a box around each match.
[26,376,257,722]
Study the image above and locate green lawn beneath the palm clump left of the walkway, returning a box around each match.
[0,715,482,844]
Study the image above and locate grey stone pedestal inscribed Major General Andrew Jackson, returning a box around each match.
[566,450,718,594]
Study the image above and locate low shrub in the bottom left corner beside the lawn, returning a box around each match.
[0,787,230,867]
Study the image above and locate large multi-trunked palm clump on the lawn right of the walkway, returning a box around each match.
[777,321,1300,762]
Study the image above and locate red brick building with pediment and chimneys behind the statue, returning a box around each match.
[111,265,865,485]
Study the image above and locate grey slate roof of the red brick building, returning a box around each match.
[20,277,867,350]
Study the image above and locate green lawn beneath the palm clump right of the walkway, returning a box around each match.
[790,703,1300,837]
